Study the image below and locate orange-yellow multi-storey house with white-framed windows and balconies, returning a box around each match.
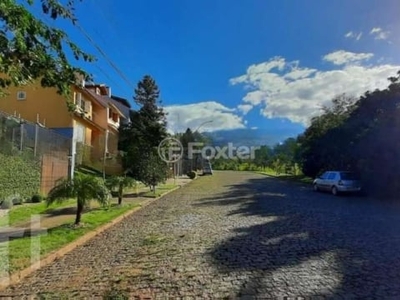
[0,81,128,173]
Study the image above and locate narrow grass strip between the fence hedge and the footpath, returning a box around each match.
[0,199,76,227]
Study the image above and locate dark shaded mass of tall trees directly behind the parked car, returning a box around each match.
[298,72,400,198]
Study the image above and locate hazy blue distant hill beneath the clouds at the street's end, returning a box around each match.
[202,129,301,147]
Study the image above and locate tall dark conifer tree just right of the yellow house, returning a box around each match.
[119,75,168,187]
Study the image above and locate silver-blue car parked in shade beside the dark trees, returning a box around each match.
[313,171,361,195]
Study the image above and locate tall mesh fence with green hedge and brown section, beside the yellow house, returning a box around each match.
[0,112,72,201]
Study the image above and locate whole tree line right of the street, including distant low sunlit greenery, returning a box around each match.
[214,71,400,197]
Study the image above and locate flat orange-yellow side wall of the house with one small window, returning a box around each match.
[0,84,72,128]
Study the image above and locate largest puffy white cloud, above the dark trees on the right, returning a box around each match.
[230,51,400,126]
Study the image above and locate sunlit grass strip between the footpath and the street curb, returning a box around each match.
[0,204,140,278]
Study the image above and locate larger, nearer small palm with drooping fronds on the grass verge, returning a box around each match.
[46,173,109,225]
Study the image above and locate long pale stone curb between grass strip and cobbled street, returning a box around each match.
[0,185,183,291]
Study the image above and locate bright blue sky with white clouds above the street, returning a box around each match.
[32,0,400,136]
